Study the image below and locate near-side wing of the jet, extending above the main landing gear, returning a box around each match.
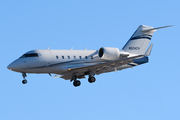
[60,55,144,80]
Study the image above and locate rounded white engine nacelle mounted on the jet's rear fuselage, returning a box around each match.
[98,47,120,60]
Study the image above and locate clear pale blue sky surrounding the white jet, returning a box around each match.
[0,0,180,120]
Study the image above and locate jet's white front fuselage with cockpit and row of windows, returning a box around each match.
[8,50,107,74]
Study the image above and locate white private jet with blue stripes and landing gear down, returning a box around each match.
[7,25,171,87]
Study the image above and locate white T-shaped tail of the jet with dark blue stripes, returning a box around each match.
[122,25,171,56]
